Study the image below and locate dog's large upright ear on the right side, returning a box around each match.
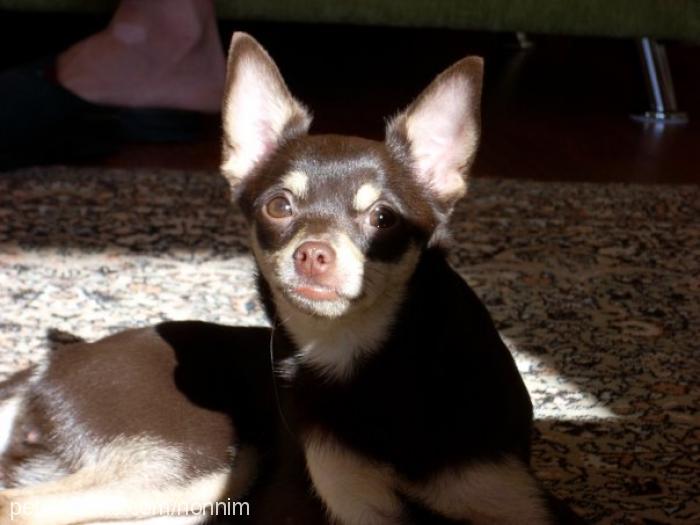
[387,57,484,213]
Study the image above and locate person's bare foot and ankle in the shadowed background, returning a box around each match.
[57,0,225,112]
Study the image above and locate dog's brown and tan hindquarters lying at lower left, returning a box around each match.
[0,323,271,525]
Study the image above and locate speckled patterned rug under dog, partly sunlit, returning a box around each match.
[0,168,700,524]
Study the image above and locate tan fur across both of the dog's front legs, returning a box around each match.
[304,433,550,525]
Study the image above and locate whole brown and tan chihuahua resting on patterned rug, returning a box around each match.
[0,33,578,525]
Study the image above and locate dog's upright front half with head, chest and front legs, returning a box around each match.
[222,35,577,525]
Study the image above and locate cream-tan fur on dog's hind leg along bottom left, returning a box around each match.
[0,440,254,525]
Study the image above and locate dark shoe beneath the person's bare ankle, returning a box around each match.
[0,58,213,171]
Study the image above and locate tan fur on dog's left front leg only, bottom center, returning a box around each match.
[305,434,401,525]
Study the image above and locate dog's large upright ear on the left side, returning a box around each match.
[221,33,311,187]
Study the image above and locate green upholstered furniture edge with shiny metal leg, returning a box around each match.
[0,0,700,122]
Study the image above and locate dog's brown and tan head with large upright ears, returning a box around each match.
[222,33,483,318]
